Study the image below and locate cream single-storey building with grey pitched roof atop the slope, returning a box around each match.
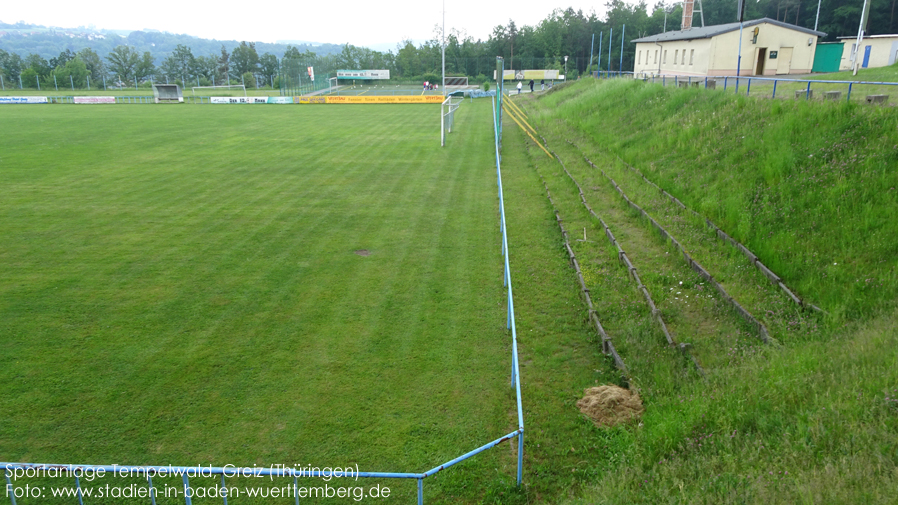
[631,17,826,76]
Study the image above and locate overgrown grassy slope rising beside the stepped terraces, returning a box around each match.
[506,81,898,503]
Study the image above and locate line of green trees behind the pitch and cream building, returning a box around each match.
[0,0,898,88]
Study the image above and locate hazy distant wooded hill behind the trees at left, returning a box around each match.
[0,21,343,65]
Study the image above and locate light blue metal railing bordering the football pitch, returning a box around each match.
[0,93,524,505]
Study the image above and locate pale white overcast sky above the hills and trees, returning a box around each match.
[0,0,605,48]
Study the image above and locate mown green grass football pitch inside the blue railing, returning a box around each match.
[0,101,516,503]
